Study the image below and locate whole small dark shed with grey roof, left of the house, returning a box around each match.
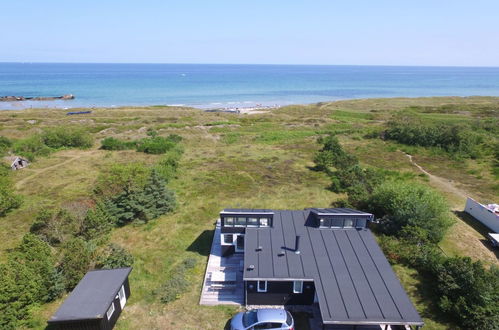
[47,267,132,330]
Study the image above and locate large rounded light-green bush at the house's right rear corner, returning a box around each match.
[366,182,451,243]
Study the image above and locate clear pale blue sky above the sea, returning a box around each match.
[0,0,499,66]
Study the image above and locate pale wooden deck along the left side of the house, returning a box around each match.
[199,223,244,305]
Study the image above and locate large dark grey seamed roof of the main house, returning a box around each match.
[244,210,423,325]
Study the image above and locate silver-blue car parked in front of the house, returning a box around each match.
[230,308,294,330]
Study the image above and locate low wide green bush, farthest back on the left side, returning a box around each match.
[41,126,93,149]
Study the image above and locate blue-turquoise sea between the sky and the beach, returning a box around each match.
[0,63,499,109]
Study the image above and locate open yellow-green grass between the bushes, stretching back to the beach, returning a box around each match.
[0,97,499,329]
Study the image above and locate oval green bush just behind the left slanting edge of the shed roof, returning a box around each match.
[60,238,92,290]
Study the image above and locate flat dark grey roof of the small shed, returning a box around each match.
[48,268,132,323]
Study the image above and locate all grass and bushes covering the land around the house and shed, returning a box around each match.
[0,97,499,329]
